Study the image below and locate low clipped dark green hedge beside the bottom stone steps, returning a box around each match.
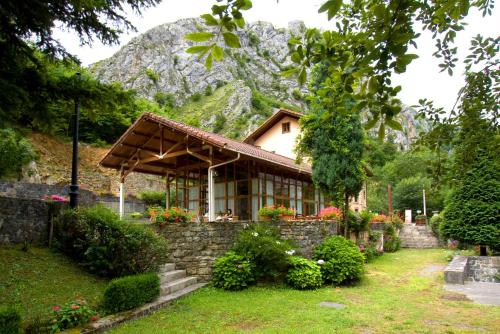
[103,273,160,313]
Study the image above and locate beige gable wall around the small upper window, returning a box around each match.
[254,116,300,159]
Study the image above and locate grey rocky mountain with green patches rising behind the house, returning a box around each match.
[91,19,421,144]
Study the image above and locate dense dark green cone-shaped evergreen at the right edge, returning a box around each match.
[441,152,500,249]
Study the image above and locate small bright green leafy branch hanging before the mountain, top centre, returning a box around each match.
[184,0,252,70]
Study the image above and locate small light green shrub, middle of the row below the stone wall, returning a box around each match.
[285,256,323,290]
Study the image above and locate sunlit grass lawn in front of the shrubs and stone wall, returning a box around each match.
[112,250,500,334]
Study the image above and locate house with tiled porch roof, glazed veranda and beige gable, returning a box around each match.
[100,109,366,221]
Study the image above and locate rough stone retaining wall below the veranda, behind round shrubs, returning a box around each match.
[156,221,337,281]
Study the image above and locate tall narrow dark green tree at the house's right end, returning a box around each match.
[298,78,365,224]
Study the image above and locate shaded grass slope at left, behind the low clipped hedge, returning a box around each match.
[0,246,108,320]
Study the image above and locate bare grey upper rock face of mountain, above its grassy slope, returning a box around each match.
[92,19,305,103]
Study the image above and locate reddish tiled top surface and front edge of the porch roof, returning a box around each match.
[101,113,312,174]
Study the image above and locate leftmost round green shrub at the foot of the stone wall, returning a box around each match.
[212,251,255,291]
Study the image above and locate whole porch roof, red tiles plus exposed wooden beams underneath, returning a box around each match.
[100,113,312,175]
